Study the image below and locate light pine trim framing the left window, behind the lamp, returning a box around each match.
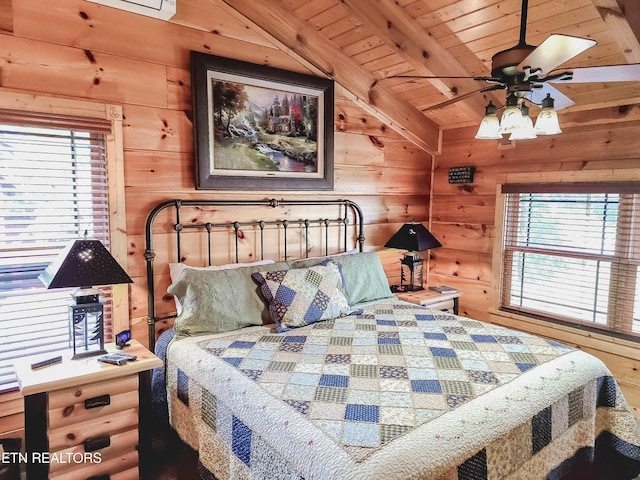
[0,92,130,358]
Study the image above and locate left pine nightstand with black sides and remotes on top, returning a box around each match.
[15,340,162,480]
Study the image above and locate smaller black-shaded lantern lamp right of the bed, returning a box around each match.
[385,223,442,292]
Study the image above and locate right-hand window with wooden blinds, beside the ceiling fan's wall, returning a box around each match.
[500,182,640,336]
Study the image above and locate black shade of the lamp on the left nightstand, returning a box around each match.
[38,239,133,288]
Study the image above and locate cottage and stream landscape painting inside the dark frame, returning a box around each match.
[212,80,318,174]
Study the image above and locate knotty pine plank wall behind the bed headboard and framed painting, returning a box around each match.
[0,0,431,435]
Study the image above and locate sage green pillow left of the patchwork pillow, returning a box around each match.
[167,262,289,338]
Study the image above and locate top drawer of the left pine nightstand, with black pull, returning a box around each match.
[48,375,138,430]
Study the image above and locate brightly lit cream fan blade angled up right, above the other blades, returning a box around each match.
[518,33,596,75]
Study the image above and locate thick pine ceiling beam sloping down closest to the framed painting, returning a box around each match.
[219,0,442,153]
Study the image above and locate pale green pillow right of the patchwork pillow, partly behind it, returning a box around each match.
[289,252,393,307]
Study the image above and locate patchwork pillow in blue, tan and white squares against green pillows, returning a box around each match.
[251,261,349,332]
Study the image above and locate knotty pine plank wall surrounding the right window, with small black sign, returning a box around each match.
[429,122,640,418]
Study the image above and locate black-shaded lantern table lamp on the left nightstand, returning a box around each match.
[38,237,133,359]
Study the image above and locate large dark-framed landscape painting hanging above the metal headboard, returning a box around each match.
[191,51,334,191]
